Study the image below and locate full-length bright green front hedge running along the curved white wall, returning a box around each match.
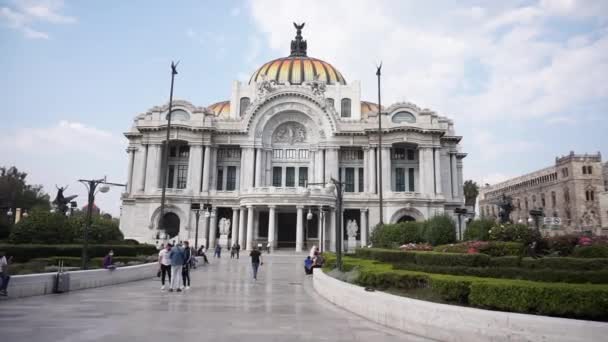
[343,257,608,321]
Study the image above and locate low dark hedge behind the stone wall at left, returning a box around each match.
[0,244,158,262]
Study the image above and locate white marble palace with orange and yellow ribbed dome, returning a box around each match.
[120,25,466,251]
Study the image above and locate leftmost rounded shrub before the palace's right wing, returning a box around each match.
[370,222,422,248]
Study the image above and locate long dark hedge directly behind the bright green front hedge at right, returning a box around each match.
[394,264,608,284]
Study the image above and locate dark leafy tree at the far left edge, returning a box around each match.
[0,166,51,239]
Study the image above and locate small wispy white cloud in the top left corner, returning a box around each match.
[0,0,76,39]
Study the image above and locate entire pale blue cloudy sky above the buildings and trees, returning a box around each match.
[0,0,608,214]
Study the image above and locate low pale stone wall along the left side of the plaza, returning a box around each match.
[6,263,158,298]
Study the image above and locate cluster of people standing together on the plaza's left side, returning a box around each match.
[158,241,196,292]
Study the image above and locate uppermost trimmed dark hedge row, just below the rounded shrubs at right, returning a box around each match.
[355,248,490,267]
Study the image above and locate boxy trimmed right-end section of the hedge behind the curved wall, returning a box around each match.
[469,280,608,320]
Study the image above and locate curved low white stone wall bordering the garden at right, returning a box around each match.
[313,269,608,342]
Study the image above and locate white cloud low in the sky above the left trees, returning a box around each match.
[0,120,127,215]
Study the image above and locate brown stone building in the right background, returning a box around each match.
[479,152,608,235]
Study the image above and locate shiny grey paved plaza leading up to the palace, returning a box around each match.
[0,255,427,342]
